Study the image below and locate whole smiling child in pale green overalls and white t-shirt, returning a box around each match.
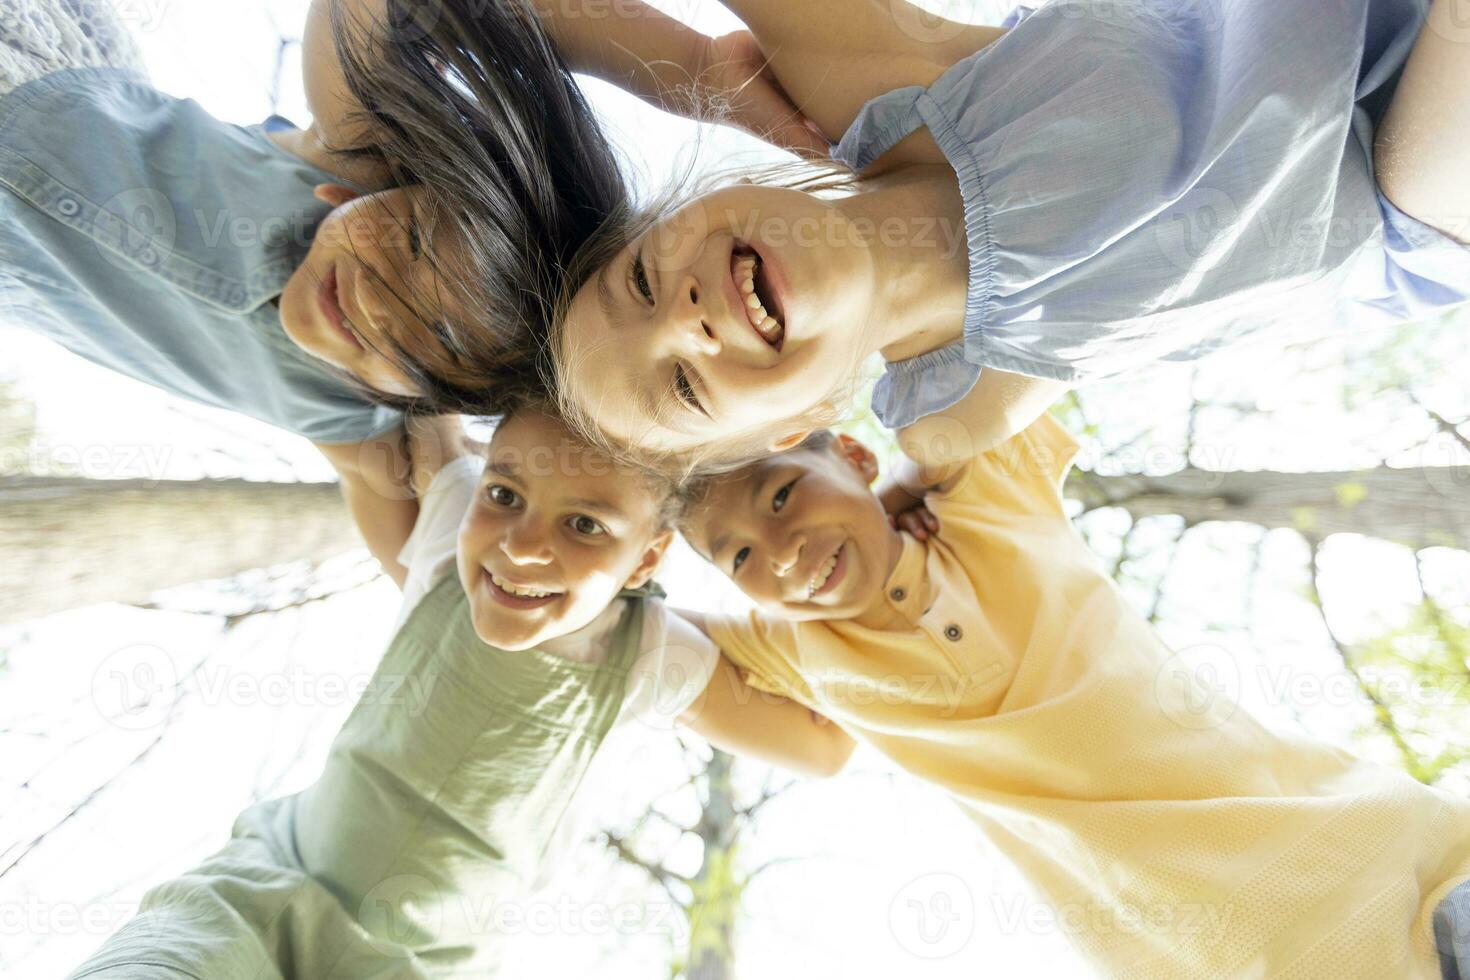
[72,407,853,980]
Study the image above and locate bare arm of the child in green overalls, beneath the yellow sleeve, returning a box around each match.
[679,658,856,777]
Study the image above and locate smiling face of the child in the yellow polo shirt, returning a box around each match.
[684,435,901,620]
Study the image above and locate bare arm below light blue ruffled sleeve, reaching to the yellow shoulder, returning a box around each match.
[889,367,1069,487]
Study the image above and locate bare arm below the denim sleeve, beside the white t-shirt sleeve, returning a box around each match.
[316,426,419,589]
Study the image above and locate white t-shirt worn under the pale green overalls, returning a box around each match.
[394,455,720,887]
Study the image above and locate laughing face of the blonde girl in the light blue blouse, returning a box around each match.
[556,185,873,453]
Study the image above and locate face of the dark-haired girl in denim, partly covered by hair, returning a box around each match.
[281,185,466,397]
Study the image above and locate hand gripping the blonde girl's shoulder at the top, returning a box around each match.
[694,31,831,157]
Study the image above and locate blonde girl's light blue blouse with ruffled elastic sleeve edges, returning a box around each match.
[833,0,1470,428]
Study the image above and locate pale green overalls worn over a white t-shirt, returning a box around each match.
[72,574,657,980]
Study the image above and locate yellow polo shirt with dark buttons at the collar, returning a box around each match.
[710,417,1470,980]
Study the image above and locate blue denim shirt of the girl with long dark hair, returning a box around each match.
[0,68,398,442]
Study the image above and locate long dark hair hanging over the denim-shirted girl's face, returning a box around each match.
[331,0,628,414]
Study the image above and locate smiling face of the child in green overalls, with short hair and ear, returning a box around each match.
[459,410,673,649]
